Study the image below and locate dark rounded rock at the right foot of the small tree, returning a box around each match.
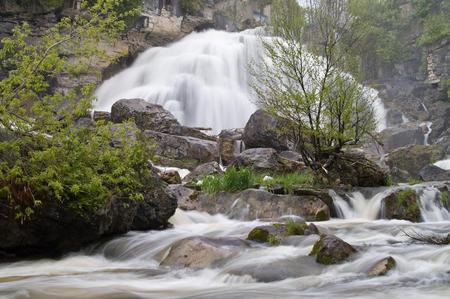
[327,153,387,187]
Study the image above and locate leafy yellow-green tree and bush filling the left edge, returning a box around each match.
[0,0,151,220]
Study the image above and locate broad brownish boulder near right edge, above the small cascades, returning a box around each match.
[386,145,445,179]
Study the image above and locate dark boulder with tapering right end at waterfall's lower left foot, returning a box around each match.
[111,99,211,139]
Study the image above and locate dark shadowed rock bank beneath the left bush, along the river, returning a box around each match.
[0,173,177,259]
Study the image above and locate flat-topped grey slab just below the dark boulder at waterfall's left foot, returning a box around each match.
[144,130,218,162]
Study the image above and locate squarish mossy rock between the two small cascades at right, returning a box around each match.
[383,188,421,222]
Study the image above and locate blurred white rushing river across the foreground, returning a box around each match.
[0,186,450,299]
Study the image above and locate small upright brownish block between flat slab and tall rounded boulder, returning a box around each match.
[218,129,244,165]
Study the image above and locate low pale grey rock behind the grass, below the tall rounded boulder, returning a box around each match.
[231,148,306,172]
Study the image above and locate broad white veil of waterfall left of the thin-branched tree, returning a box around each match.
[94,30,260,133]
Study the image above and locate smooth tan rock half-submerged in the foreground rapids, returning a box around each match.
[161,237,248,268]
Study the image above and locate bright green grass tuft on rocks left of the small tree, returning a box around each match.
[201,166,253,194]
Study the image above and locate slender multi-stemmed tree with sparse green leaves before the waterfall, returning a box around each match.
[251,0,375,172]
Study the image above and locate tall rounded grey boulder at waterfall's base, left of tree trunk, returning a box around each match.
[243,109,288,151]
